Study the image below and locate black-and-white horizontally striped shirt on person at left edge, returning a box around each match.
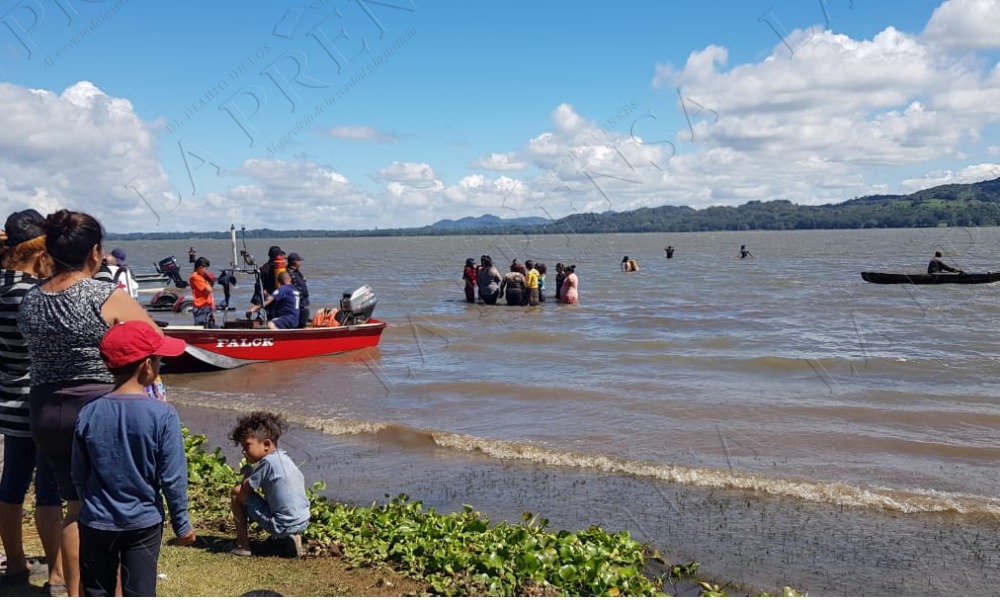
[0,269,38,437]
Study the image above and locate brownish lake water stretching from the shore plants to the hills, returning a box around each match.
[120,229,1000,595]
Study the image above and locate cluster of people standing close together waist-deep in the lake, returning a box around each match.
[462,254,579,306]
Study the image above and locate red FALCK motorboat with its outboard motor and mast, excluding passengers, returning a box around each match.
[163,227,386,373]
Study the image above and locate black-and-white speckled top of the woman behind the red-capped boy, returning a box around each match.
[17,279,118,385]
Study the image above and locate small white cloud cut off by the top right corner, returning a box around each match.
[923,0,1000,50]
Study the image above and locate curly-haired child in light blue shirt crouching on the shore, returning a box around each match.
[229,411,309,556]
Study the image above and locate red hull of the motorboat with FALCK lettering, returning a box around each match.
[163,319,386,373]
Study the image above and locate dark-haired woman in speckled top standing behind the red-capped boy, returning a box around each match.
[17,210,160,596]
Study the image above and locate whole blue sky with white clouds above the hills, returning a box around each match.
[0,0,1000,233]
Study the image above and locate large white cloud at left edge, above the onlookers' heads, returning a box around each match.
[0,81,177,230]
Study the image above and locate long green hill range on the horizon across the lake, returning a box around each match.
[108,178,1000,240]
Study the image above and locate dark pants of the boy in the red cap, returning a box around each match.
[80,523,163,597]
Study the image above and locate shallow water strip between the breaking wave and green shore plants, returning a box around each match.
[168,398,996,596]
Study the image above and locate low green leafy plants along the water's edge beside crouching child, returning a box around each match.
[184,430,663,596]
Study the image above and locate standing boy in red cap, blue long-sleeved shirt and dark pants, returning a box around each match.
[72,321,195,596]
